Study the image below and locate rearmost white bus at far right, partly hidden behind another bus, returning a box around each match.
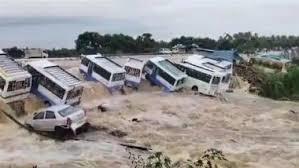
[183,55,233,93]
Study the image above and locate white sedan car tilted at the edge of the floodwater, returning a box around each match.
[25,105,88,134]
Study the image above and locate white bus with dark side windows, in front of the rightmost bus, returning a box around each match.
[177,62,224,96]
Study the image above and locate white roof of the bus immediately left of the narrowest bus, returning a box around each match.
[85,54,125,73]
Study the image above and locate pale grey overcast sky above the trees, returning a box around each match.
[0,0,299,48]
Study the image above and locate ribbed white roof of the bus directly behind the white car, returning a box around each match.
[28,60,81,87]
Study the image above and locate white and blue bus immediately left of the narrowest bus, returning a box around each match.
[80,54,125,91]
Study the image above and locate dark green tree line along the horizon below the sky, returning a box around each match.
[5,32,299,58]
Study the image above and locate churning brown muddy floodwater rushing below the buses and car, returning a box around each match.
[0,55,299,168]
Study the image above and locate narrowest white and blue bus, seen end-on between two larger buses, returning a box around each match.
[124,58,144,88]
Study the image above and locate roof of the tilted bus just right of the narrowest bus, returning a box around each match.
[150,57,187,79]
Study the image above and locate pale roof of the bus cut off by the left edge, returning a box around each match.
[0,55,31,77]
